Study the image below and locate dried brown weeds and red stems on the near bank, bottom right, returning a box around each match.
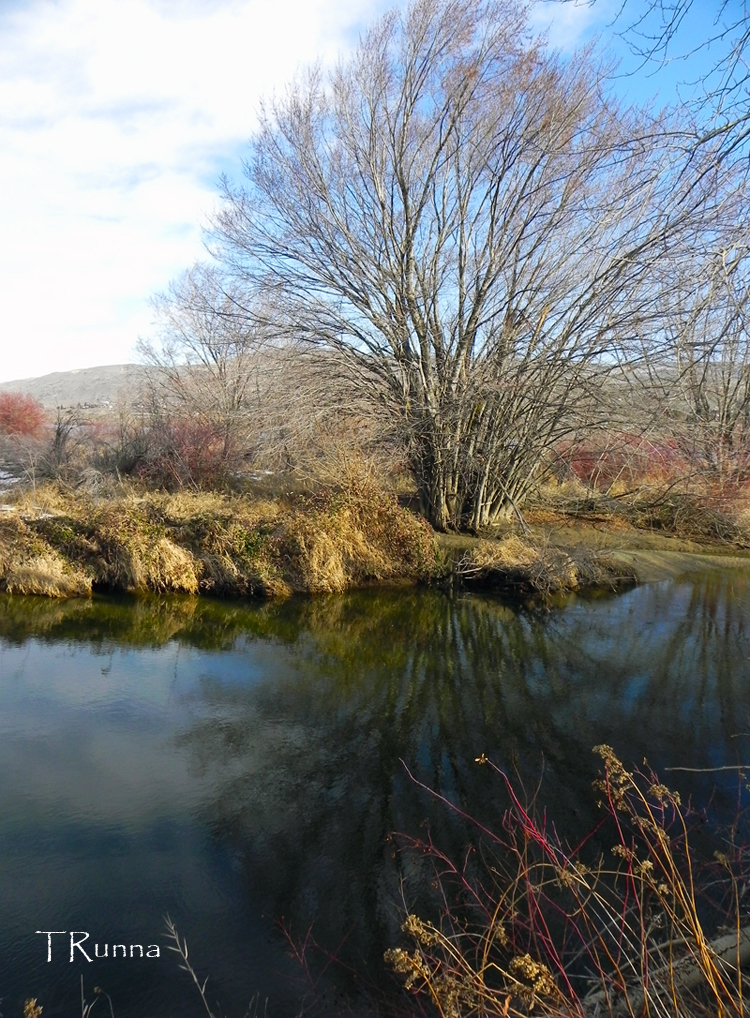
[386,746,750,1018]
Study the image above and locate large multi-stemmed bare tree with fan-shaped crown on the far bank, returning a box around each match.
[209,0,712,529]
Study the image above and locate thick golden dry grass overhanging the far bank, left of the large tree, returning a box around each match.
[0,485,436,597]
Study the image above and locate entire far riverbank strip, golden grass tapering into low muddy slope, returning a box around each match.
[0,486,750,598]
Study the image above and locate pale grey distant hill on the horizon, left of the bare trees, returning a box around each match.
[0,364,149,409]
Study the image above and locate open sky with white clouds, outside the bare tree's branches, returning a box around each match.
[0,0,715,382]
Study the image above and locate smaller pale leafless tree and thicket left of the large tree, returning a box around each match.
[136,265,398,487]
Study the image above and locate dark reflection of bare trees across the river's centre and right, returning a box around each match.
[172,573,750,1001]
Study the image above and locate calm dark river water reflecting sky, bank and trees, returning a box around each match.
[0,572,750,1018]
